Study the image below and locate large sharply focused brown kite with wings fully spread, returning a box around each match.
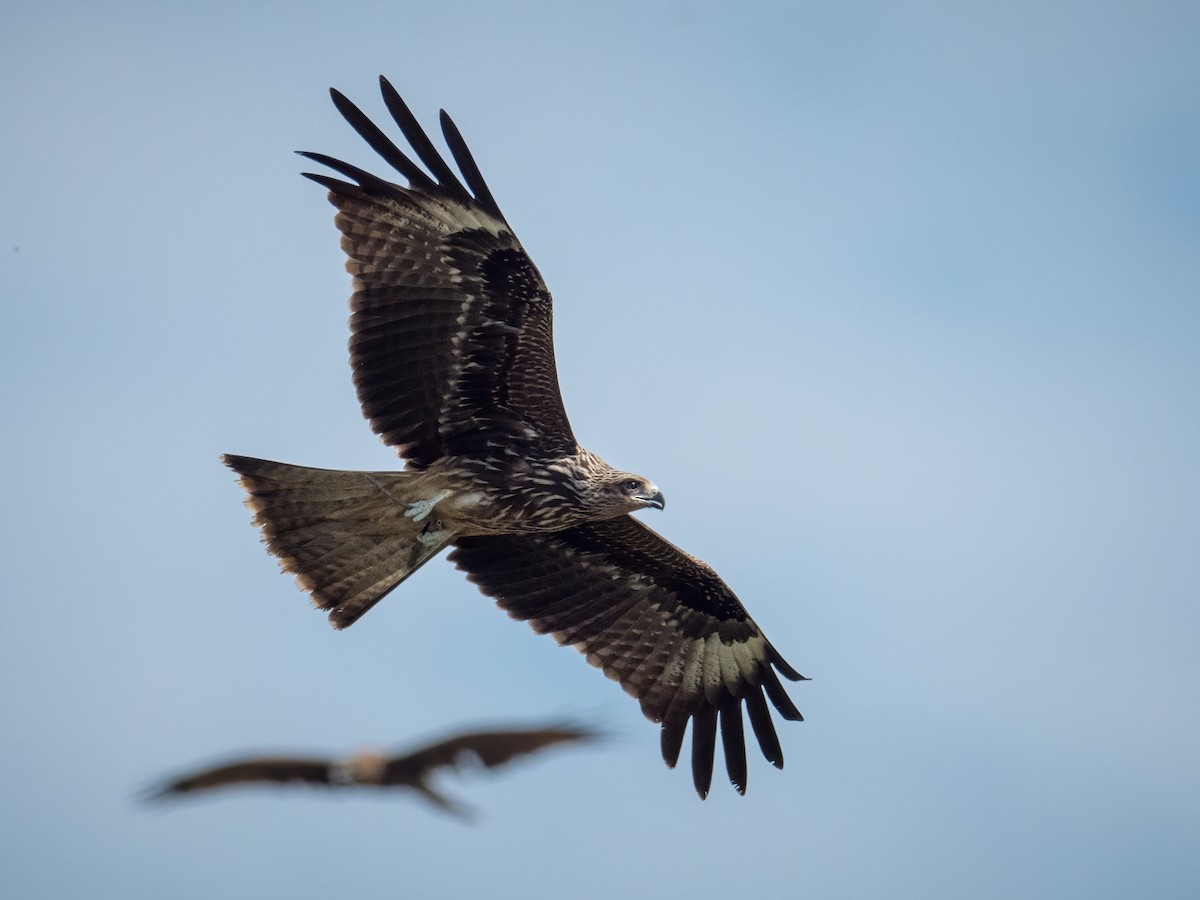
[222,78,803,798]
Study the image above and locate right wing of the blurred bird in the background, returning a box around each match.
[379,725,599,785]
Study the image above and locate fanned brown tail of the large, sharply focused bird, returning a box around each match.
[221,454,454,629]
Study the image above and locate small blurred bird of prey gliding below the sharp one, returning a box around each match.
[146,725,599,817]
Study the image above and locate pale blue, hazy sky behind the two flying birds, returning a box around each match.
[0,0,1200,899]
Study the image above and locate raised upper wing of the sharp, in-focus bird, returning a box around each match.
[302,78,575,468]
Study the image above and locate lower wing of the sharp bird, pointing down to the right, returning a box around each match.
[450,516,803,797]
